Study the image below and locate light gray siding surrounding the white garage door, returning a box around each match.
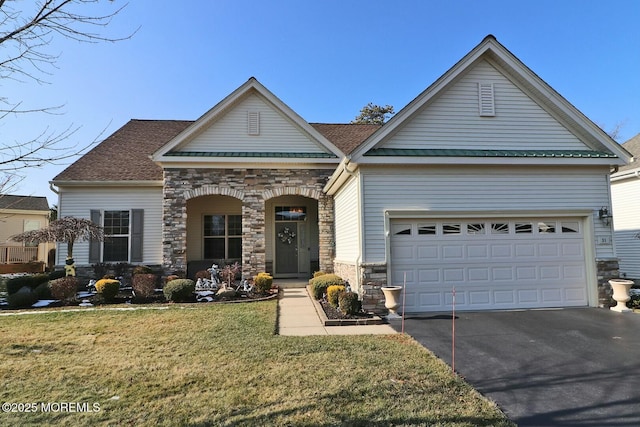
[361,166,613,262]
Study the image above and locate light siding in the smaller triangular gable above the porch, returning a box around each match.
[179,94,327,153]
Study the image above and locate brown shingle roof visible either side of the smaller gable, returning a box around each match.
[54,120,380,181]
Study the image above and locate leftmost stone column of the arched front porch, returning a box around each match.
[162,177,187,274]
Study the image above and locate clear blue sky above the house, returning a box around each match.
[0,0,640,204]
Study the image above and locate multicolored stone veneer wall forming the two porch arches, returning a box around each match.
[162,168,334,277]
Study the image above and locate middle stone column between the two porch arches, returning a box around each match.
[242,194,266,278]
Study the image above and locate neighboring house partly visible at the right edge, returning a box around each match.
[611,134,640,279]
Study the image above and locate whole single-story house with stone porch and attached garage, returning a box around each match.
[52,36,631,312]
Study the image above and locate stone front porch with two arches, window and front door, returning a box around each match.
[163,169,334,280]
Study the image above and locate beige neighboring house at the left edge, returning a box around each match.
[0,194,53,264]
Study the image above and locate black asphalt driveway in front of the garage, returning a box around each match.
[391,308,640,427]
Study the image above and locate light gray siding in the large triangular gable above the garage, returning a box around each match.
[380,61,586,150]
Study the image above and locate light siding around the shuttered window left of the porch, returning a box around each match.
[56,187,162,265]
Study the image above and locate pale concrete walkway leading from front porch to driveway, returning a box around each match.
[278,287,398,336]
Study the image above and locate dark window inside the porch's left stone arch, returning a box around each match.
[203,215,242,259]
